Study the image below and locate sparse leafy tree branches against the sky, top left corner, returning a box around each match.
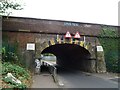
[0,0,23,16]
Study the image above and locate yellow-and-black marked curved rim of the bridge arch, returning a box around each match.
[41,38,94,57]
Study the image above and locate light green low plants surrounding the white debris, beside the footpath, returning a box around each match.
[2,62,31,88]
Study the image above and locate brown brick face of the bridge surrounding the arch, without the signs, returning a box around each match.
[2,17,115,72]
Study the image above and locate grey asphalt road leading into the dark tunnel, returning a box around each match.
[58,70,118,88]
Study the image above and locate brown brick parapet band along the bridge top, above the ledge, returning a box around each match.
[3,17,101,35]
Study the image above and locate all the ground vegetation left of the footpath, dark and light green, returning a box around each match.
[0,41,32,90]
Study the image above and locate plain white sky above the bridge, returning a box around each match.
[12,0,120,26]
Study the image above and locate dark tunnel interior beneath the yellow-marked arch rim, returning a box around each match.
[41,44,91,71]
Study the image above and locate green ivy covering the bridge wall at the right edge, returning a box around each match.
[99,26,120,72]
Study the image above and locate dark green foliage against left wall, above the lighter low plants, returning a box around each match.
[2,35,20,63]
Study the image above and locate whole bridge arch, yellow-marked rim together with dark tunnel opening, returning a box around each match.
[41,38,95,72]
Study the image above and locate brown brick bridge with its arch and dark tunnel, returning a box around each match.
[2,17,112,72]
